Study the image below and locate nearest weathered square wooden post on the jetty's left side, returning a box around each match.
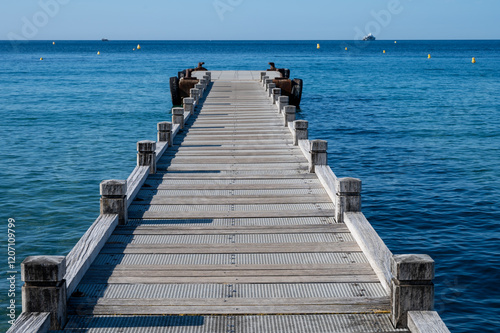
[21,256,68,330]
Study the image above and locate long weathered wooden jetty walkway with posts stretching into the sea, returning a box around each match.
[11,71,448,333]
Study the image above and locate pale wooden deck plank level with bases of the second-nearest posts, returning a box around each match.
[133,209,335,219]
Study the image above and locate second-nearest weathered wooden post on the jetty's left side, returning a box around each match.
[100,179,128,225]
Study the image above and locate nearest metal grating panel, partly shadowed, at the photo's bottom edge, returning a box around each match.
[53,314,409,333]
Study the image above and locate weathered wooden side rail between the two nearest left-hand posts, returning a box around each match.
[64,215,118,298]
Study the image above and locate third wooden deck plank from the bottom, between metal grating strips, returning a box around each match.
[101,242,361,254]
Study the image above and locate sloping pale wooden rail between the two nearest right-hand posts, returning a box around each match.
[344,213,392,295]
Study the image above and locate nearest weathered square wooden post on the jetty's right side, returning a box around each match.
[391,254,434,328]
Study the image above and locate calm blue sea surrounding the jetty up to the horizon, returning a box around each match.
[0,41,500,332]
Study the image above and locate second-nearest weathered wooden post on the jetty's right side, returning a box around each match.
[335,178,361,223]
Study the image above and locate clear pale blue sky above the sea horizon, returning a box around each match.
[0,0,500,40]
